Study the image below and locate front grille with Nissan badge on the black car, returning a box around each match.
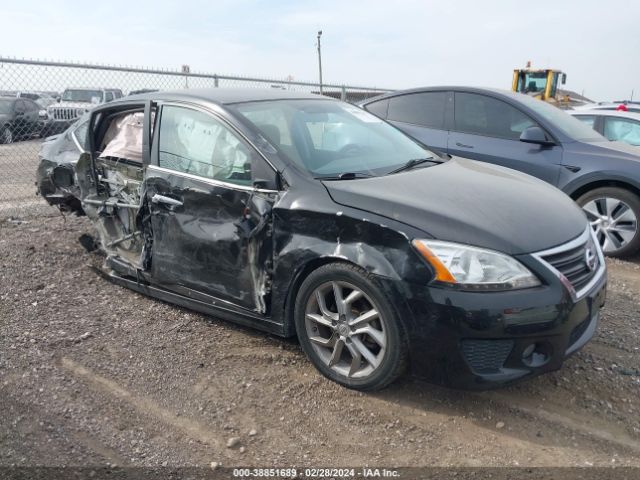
[541,235,600,292]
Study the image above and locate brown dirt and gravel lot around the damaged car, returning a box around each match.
[0,217,640,467]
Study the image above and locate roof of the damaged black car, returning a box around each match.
[124,88,324,105]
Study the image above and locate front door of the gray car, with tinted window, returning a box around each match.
[448,92,562,185]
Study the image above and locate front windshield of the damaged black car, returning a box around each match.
[232,100,436,178]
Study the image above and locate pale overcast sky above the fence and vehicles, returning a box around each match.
[0,0,640,100]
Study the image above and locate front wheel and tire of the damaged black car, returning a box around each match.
[294,263,408,391]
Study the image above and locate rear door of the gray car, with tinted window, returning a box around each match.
[386,91,453,152]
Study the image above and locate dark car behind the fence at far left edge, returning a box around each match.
[0,97,40,143]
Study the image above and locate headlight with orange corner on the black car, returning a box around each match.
[413,240,540,290]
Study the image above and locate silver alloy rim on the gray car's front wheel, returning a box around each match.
[582,197,638,253]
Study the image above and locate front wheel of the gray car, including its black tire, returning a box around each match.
[577,187,640,257]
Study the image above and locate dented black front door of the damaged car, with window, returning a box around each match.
[145,104,278,314]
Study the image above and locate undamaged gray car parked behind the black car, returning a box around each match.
[361,87,640,257]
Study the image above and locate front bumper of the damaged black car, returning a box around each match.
[403,258,607,389]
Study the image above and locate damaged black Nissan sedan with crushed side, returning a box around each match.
[38,89,606,390]
